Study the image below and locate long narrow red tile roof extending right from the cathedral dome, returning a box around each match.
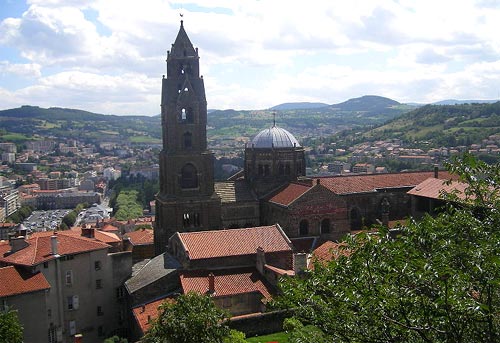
[319,171,451,194]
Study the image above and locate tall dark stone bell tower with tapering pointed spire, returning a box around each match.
[154,21,221,255]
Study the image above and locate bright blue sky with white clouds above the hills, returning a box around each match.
[0,0,500,115]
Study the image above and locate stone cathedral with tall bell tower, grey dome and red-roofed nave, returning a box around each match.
[154,21,448,255]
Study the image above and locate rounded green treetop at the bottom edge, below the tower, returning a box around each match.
[143,292,230,343]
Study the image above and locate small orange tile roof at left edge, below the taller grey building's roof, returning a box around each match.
[0,266,50,298]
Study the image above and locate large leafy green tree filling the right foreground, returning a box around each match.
[274,155,500,343]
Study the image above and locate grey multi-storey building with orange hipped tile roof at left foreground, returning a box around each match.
[0,231,132,343]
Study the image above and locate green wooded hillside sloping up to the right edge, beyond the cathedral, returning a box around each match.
[362,102,500,146]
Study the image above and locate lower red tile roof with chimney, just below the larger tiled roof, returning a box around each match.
[179,267,272,299]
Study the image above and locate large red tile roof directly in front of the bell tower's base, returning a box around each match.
[178,224,293,260]
